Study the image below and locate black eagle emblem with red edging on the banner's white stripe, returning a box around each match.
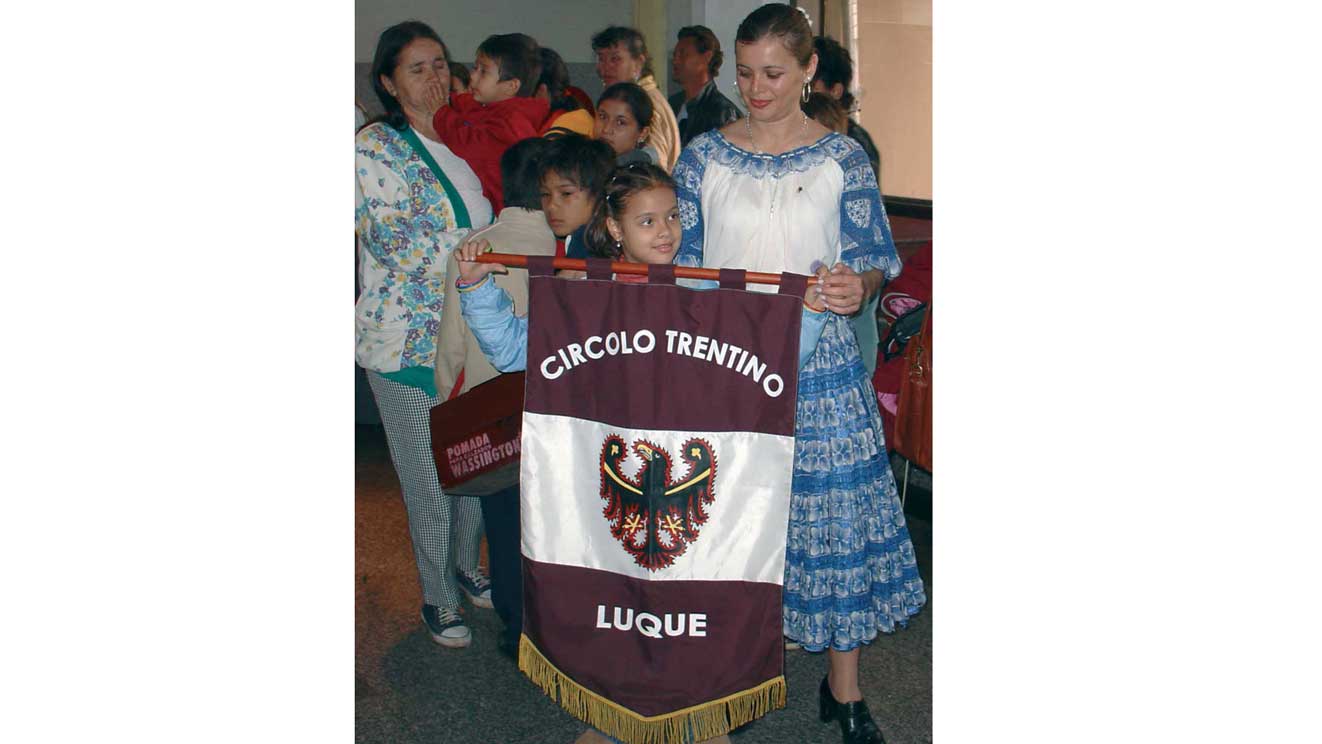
[602,433,717,571]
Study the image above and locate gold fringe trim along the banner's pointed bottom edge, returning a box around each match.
[518,636,785,744]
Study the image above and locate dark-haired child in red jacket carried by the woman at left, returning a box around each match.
[432,33,550,214]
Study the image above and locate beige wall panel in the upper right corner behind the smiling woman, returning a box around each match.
[854,0,932,200]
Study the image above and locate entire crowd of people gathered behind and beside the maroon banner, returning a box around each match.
[356,3,927,744]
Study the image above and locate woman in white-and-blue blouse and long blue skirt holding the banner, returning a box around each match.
[674,4,927,744]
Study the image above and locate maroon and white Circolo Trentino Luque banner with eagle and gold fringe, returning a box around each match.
[520,263,804,744]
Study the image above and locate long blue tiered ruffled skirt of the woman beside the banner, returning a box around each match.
[784,316,927,651]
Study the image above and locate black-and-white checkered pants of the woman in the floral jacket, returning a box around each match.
[368,370,483,611]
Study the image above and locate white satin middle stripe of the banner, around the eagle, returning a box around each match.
[521,412,795,585]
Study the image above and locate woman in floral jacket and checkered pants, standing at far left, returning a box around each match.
[354,21,492,648]
